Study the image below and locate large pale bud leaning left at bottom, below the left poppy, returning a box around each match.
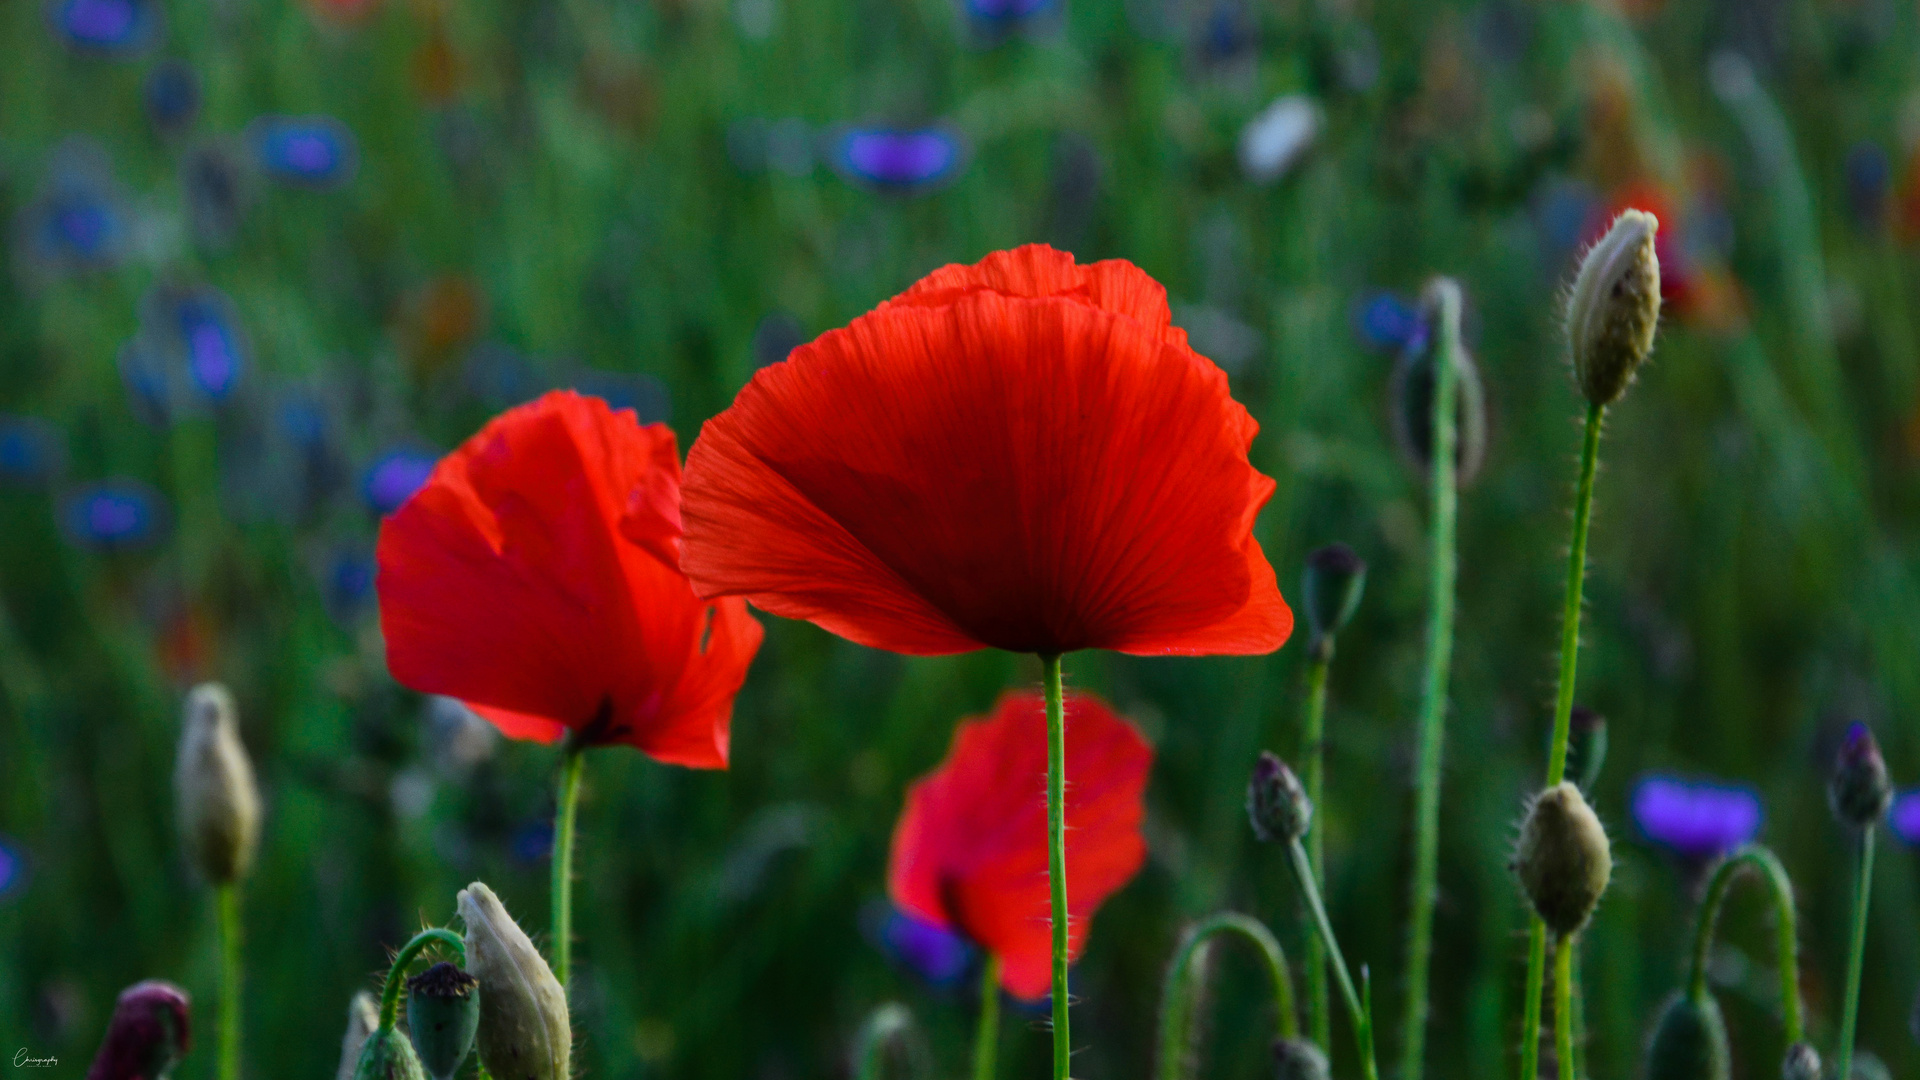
[459,882,574,1080]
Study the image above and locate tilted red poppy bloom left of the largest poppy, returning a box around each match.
[378,390,762,769]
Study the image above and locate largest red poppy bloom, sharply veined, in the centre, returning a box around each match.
[682,246,1292,655]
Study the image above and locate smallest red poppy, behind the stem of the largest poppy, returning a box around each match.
[887,692,1154,1001]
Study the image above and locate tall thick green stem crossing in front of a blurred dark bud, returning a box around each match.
[1405,270,1459,1080]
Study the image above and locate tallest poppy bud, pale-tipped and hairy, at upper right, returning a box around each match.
[1567,209,1661,405]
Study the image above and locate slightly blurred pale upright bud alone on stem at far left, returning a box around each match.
[173,682,259,886]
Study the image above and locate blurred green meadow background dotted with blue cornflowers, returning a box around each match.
[0,0,1920,1060]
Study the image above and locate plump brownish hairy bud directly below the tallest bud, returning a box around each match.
[1513,782,1613,938]
